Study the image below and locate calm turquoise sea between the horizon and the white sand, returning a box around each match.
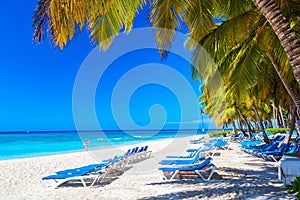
[0,130,212,160]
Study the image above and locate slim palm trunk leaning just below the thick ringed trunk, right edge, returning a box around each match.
[268,54,300,110]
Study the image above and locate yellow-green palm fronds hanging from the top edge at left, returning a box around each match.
[32,0,146,50]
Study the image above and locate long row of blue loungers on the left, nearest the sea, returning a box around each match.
[41,146,151,188]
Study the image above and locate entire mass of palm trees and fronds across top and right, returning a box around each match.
[33,0,300,142]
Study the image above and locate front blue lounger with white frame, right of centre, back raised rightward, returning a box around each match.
[159,158,216,181]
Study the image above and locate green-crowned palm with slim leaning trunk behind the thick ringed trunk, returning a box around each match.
[189,2,299,110]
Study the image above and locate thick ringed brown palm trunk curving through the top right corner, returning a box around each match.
[252,0,300,84]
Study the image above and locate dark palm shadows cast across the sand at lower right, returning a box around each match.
[142,166,295,200]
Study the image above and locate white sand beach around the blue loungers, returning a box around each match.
[0,137,295,200]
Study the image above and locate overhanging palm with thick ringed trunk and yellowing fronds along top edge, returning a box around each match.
[33,0,300,74]
